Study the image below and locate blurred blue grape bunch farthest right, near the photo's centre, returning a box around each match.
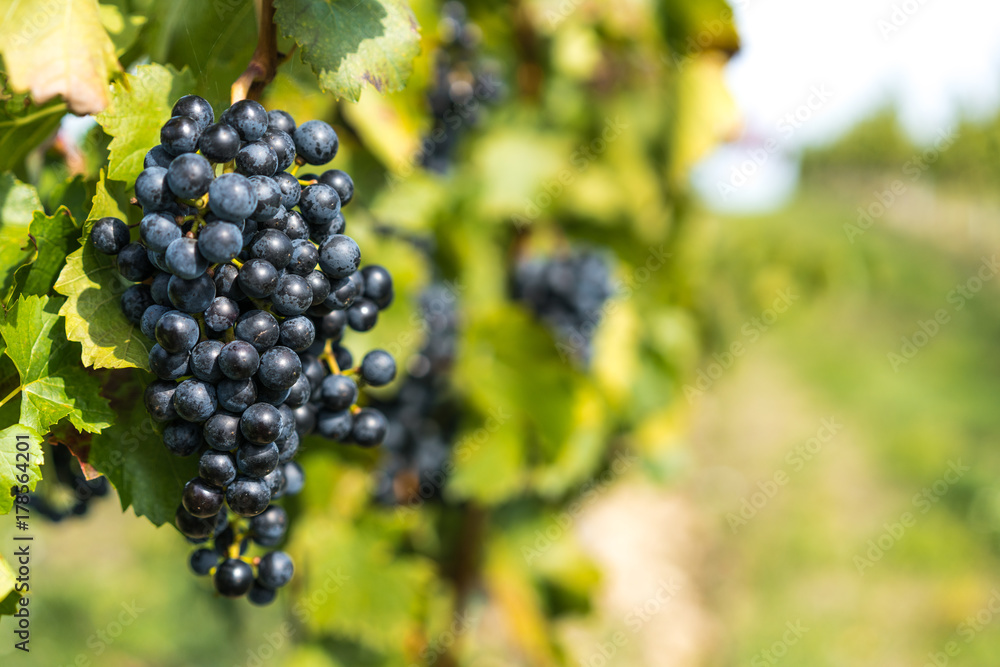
[511,251,614,366]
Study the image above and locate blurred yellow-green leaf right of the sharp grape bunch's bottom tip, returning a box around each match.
[289,514,433,649]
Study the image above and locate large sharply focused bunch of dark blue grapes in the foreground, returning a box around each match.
[91,95,396,604]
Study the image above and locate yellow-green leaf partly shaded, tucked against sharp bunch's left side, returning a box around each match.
[55,174,152,370]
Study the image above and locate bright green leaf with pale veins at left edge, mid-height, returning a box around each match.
[0,295,114,433]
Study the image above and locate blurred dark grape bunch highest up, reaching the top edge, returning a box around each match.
[420,2,503,173]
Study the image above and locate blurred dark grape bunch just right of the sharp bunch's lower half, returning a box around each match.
[375,283,459,505]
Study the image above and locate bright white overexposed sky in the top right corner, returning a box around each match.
[695,0,1000,210]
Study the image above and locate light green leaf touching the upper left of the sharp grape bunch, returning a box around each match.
[97,64,194,183]
